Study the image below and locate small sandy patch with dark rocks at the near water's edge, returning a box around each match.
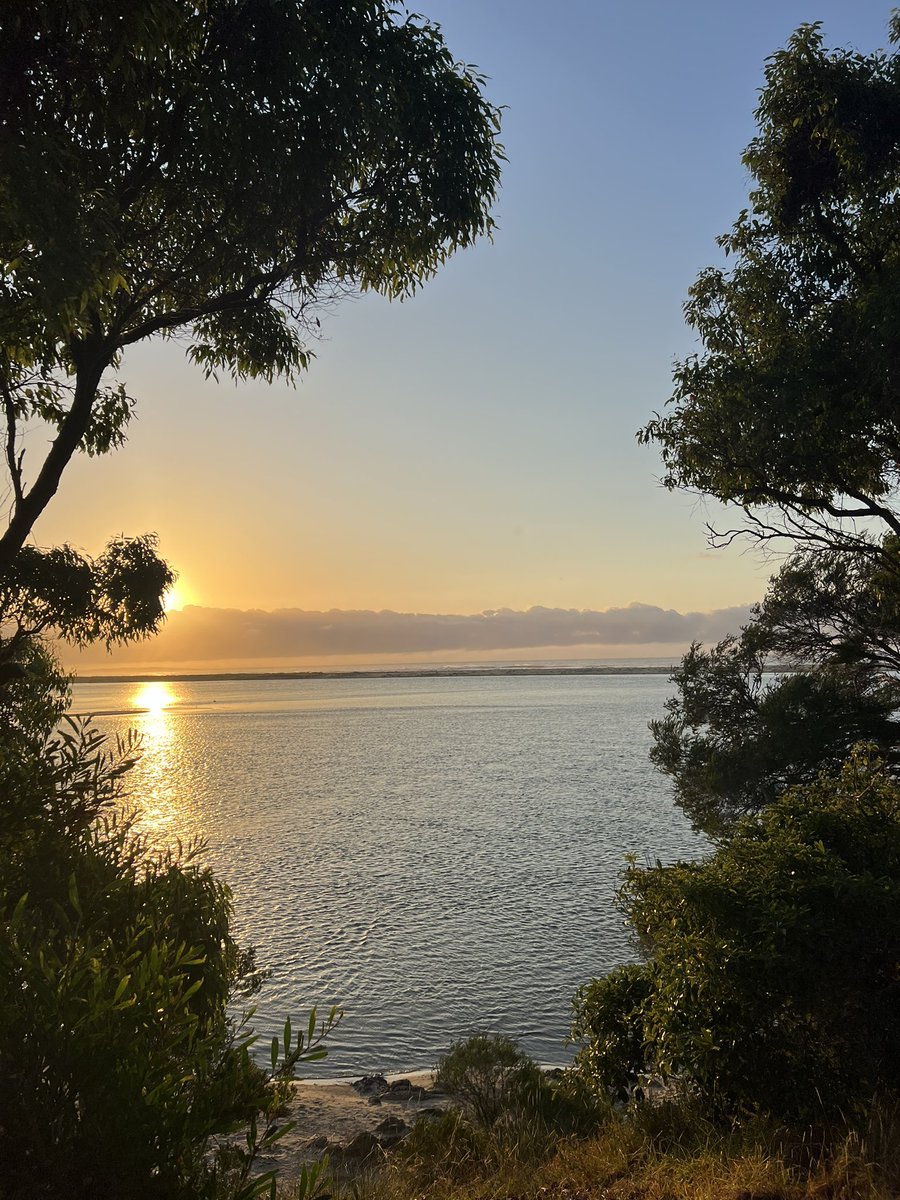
[247,1072,450,1176]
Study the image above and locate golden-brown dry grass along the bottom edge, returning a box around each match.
[282,1105,900,1200]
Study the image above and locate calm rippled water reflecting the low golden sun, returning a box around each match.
[73,676,702,1076]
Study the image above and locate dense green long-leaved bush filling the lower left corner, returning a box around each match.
[0,662,337,1200]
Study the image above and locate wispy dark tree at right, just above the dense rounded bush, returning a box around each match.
[650,561,900,838]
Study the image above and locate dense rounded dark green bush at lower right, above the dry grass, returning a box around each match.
[575,751,900,1121]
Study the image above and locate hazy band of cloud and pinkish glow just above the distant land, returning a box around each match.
[60,604,750,673]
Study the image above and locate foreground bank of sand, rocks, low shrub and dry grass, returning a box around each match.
[266,1051,900,1200]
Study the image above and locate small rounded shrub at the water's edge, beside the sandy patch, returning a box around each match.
[434,1033,542,1128]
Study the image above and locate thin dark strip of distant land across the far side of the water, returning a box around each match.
[68,662,792,684]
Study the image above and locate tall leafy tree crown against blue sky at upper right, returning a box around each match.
[641,19,900,557]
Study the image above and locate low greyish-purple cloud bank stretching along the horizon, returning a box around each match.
[65,604,750,665]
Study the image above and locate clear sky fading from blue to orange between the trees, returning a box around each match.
[44,0,889,667]
